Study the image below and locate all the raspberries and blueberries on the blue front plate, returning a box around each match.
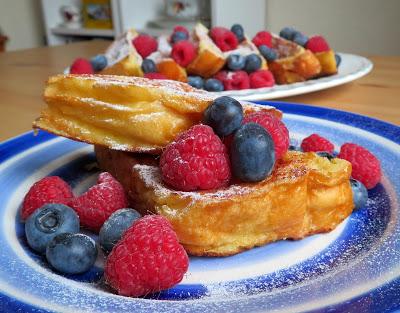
[20,96,381,297]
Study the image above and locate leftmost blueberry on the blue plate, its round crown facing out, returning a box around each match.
[25,203,79,253]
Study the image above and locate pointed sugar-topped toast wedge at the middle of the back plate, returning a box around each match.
[186,23,225,78]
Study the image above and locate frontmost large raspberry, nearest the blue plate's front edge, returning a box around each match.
[104,215,189,297]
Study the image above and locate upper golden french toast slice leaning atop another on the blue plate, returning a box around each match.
[33,75,282,154]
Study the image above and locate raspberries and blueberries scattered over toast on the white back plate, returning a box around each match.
[70,24,340,92]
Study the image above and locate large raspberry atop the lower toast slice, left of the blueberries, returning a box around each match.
[160,125,231,191]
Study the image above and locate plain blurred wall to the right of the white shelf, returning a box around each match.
[266,0,400,55]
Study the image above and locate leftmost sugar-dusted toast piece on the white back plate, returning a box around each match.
[99,29,143,77]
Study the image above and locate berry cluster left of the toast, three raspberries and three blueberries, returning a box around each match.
[21,172,189,296]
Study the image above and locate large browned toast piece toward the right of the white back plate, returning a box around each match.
[269,36,321,84]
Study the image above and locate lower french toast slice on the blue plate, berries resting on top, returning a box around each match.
[95,146,354,256]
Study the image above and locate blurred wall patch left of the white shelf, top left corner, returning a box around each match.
[0,0,44,51]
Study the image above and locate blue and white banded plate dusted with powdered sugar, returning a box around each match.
[0,102,400,313]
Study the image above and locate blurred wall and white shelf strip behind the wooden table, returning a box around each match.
[0,0,400,55]
